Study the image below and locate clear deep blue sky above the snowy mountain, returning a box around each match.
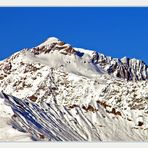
[0,7,148,64]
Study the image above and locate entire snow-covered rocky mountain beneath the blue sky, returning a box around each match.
[0,38,148,141]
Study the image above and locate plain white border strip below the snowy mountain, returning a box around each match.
[0,142,148,148]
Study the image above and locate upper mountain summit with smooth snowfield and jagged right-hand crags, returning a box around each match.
[0,37,148,81]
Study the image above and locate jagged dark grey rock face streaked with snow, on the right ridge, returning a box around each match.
[92,52,148,81]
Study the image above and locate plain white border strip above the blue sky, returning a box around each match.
[0,0,148,7]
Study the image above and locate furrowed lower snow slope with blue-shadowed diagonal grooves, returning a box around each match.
[0,90,148,141]
